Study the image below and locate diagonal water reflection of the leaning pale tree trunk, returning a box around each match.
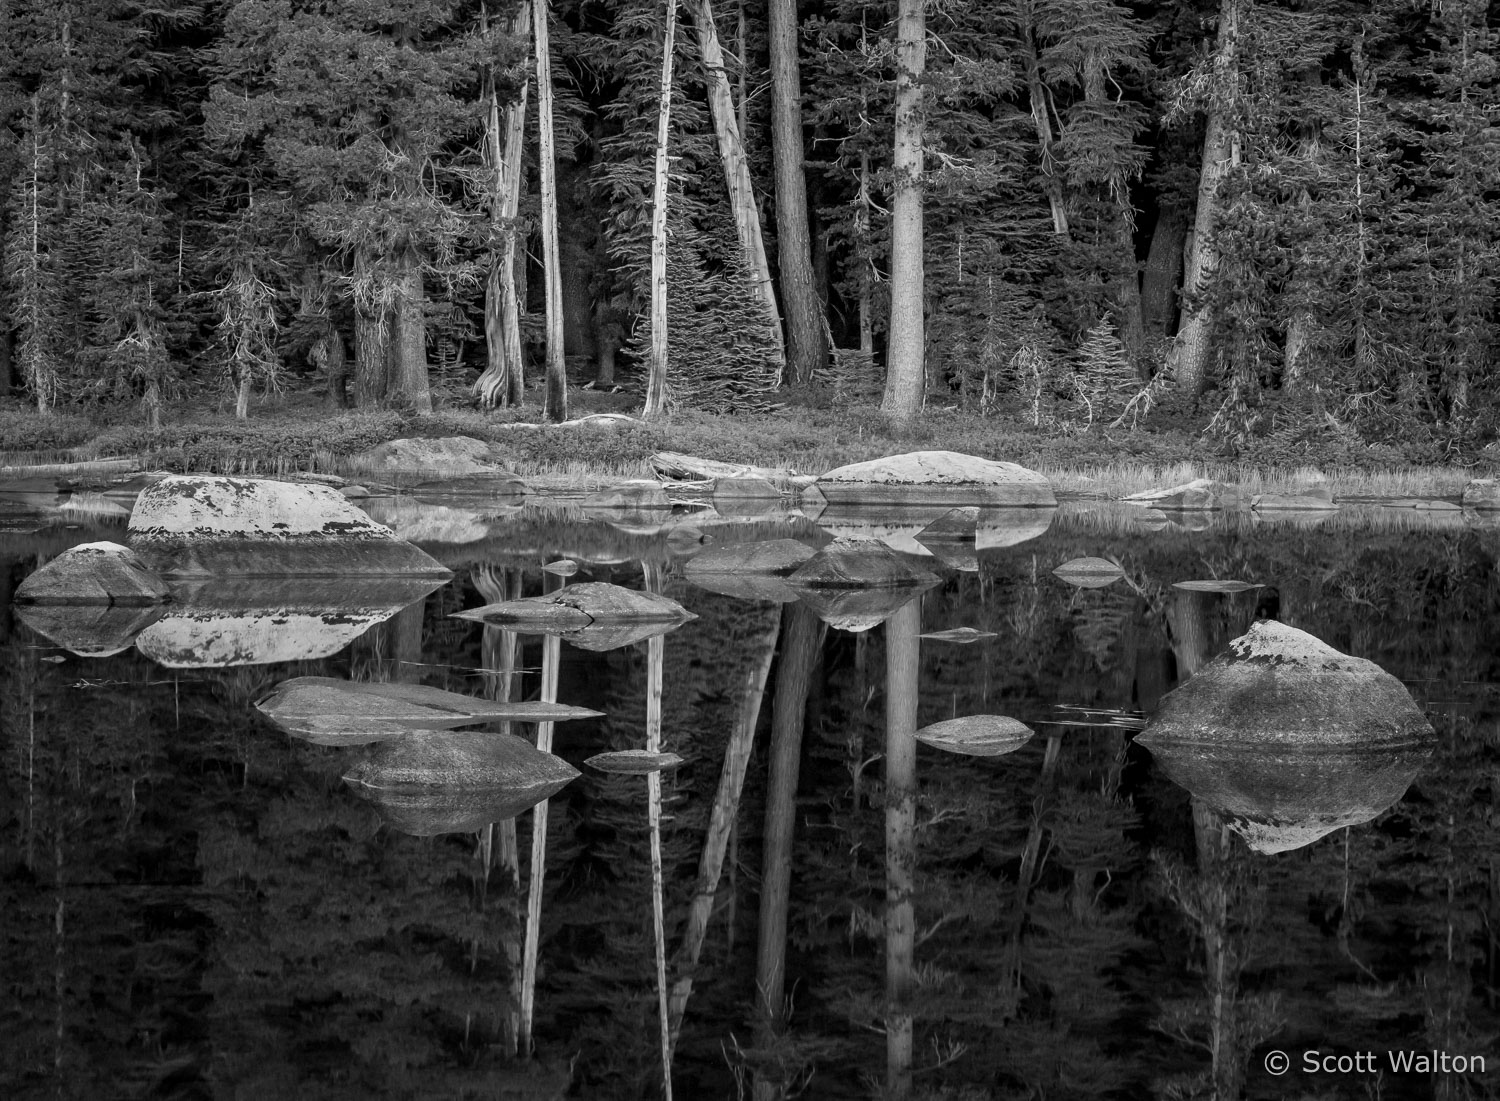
[671,614,782,1044]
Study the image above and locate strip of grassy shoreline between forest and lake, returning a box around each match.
[0,392,1500,498]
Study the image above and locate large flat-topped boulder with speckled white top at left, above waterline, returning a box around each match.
[131,474,449,579]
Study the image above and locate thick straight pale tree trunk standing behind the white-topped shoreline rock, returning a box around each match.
[881,0,927,423]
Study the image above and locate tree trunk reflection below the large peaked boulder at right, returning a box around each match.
[1193,800,1247,1101]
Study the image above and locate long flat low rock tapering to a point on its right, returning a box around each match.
[255,677,602,746]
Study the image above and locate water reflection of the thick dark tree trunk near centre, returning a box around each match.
[755,603,825,1101]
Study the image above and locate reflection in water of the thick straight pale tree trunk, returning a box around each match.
[885,600,923,1101]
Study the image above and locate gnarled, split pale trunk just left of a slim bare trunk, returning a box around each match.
[474,3,531,408]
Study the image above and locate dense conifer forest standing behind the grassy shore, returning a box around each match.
[0,0,1500,455]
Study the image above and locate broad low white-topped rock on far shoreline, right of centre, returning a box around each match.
[818,452,1058,507]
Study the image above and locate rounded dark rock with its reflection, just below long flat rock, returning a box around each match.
[344,731,578,837]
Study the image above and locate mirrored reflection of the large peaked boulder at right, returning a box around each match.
[1151,743,1431,852]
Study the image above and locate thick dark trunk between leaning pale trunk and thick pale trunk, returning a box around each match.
[767,0,828,383]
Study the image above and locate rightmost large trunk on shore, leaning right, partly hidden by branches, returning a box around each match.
[1167,0,1253,398]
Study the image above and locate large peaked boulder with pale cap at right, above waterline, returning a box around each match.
[1139,620,1433,749]
